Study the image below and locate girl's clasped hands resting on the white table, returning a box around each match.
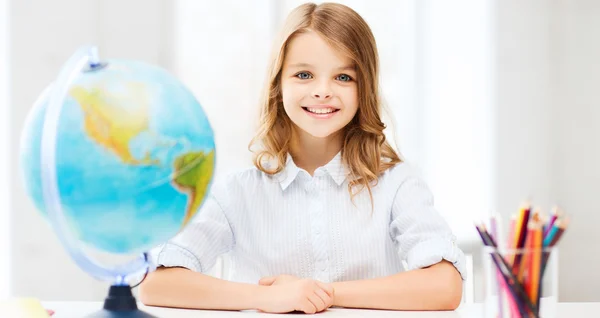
[257,276,334,314]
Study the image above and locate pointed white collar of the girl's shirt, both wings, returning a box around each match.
[278,151,348,190]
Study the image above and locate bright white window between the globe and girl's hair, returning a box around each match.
[173,0,275,177]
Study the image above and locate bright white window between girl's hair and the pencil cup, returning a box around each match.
[410,0,495,242]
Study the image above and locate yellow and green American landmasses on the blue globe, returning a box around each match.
[69,82,214,226]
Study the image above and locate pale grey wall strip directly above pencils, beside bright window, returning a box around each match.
[495,1,553,220]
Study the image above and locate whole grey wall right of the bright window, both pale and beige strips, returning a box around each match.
[495,0,600,301]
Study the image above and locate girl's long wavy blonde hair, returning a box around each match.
[249,3,401,202]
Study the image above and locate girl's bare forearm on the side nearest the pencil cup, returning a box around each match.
[332,261,462,310]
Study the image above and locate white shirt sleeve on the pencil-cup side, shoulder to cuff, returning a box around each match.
[390,176,466,280]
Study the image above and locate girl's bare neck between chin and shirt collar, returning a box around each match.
[290,127,344,176]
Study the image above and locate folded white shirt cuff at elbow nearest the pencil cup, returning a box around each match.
[406,238,467,280]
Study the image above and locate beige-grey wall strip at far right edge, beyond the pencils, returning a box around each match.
[549,0,600,301]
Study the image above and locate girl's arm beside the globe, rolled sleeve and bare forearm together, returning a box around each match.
[140,183,264,309]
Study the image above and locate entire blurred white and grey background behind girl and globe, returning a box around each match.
[0,0,600,301]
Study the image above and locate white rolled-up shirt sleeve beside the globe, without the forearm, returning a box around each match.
[152,188,235,272]
